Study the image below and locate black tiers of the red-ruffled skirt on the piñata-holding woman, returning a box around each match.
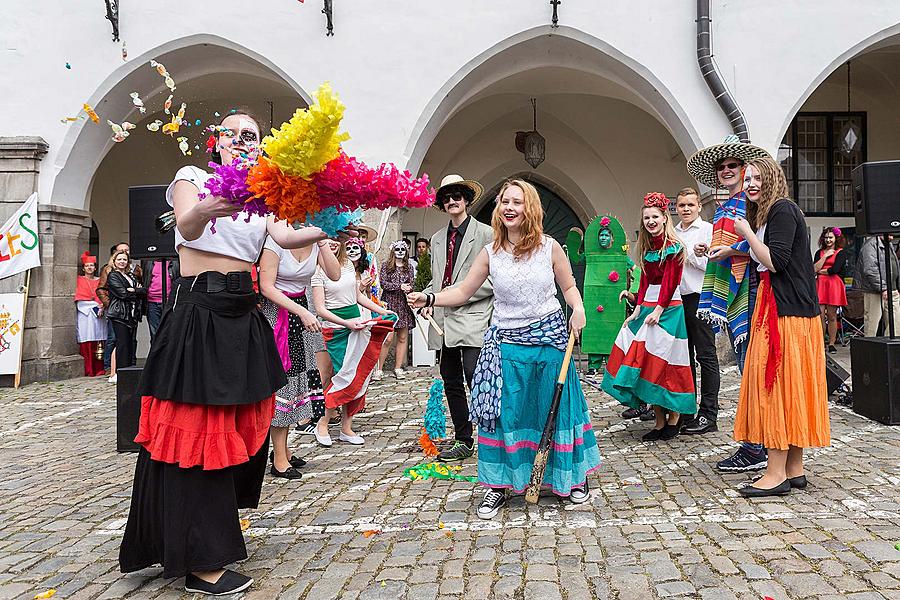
[119,273,286,577]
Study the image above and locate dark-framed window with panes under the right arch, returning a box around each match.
[778,112,866,216]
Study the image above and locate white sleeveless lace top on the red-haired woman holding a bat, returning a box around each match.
[484,235,561,329]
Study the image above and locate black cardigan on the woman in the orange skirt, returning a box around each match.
[763,199,820,317]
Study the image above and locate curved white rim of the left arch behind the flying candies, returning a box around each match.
[50,34,311,210]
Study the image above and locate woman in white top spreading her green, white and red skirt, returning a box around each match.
[311,238,396,447]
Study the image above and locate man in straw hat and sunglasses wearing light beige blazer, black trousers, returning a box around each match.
[421,175,494,462]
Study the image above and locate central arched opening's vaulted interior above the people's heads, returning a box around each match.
[403,27,699,248]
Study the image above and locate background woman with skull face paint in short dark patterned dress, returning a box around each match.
[374,240,416,380]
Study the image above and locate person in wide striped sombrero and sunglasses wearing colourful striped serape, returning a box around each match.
[686,135,769,472]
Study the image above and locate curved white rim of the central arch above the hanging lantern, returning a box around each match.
[405,26,702,172]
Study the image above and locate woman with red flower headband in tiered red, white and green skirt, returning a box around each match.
[602,192,697,442]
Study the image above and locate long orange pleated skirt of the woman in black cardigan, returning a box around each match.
[734,283,831,450]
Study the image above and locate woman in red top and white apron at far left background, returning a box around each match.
[75,252,106,377]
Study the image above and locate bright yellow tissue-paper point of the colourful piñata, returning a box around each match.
[262,83,350,178]
